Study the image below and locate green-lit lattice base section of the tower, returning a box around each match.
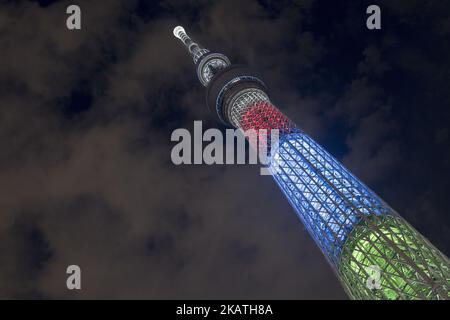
[339,216,450,300]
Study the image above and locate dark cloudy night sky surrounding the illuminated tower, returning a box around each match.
[0,0,450,299]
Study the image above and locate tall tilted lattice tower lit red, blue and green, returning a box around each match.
[174,27,450,299]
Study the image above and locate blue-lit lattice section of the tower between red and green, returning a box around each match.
[270,130,396,266]
